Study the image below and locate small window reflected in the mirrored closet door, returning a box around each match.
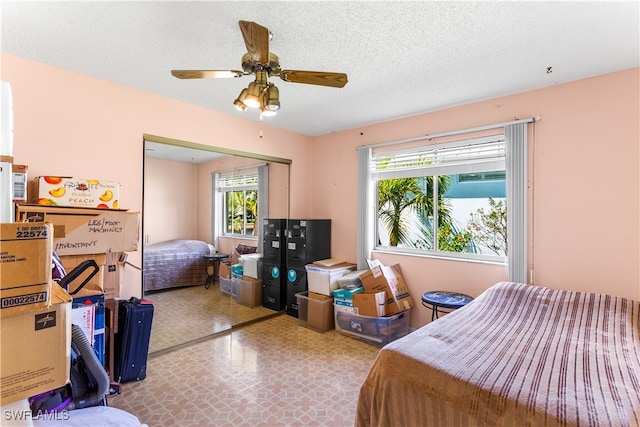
[217,172,258,236]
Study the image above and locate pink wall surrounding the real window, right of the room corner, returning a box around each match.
[312,69,640,326]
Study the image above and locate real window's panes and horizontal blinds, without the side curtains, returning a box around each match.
[370,134,507,260]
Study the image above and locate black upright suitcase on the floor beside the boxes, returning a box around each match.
[114,297,153,382]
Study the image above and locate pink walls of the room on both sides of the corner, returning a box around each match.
[1,54,640,327]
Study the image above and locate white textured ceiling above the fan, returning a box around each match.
[0,1,640,136]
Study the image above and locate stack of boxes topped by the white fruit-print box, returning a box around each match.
[15,176,139,382]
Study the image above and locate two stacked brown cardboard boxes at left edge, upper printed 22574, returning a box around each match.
[0,222,71,406]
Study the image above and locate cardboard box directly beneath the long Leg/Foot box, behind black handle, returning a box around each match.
[60,252,127,298]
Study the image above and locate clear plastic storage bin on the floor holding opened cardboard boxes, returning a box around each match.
[334,310,410,347]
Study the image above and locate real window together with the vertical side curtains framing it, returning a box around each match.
[358,123,533,283]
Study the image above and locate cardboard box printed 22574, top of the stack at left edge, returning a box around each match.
[0,222,53,316]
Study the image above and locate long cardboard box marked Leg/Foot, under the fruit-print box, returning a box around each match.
[16,205,140,256]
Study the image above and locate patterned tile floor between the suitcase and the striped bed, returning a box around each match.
[109,315,379,427]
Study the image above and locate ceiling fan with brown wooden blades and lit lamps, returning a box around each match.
[171,21,347,115]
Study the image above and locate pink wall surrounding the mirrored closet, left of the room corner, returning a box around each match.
[0,53,312,297]
